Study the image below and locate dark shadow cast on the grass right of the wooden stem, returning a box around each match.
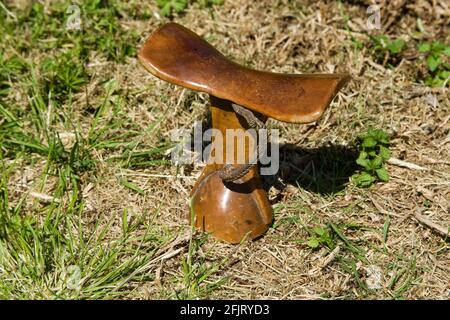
[263,144,358,195]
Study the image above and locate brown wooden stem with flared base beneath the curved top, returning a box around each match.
[191,96,273,243]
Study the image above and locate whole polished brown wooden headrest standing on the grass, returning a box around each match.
[139,23,349,243]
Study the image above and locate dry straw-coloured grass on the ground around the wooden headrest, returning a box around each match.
[0,0,450,299]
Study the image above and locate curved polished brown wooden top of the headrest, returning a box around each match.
[139,23,349,123]
